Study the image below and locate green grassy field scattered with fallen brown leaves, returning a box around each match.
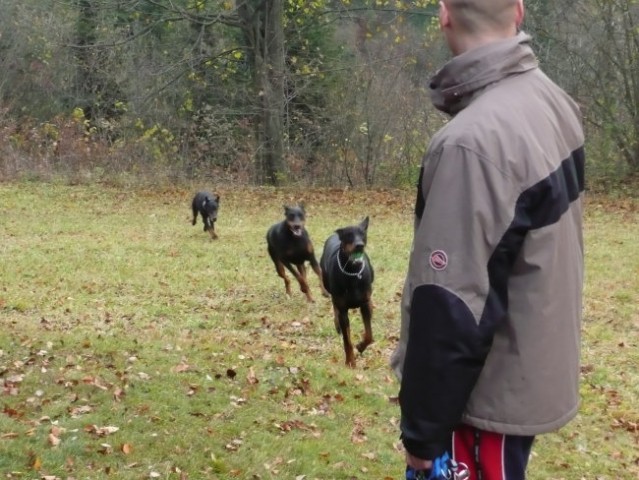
[0,183,639,480]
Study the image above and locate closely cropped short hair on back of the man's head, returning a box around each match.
[443,0,518,34]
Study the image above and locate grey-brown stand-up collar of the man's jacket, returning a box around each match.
[430,32,538,115]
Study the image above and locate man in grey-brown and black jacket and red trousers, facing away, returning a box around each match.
[391,0,584,480]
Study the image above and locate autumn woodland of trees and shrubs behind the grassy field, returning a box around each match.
[0,0,639,192]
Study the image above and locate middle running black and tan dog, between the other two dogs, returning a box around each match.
[266,205,328,302]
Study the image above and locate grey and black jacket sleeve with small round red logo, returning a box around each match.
[399,146,517,459]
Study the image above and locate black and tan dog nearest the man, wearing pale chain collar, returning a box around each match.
[320,217,374,367]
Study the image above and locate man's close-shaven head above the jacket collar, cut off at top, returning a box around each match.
[439,0,524,55]
